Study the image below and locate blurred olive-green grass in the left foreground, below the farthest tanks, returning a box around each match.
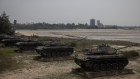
[0,48,18,73]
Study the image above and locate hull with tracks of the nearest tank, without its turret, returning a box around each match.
[74,55,128,71]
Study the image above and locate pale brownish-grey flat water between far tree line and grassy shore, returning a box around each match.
[16,29,140,43]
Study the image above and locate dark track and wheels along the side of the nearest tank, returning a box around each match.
[75,58,128,71]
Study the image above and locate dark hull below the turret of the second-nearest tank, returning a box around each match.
[36,47,73,58]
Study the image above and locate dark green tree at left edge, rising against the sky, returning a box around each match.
[0,12,15,35]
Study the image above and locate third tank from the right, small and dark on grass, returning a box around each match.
[16,41,43,51]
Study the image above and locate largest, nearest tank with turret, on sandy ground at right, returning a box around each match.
[74,44,128,71]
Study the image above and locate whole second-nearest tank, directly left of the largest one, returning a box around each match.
[36,42,73,58]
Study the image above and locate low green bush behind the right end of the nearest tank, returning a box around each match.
[121,50,139,58]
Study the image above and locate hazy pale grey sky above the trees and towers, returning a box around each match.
[0,0,140,25]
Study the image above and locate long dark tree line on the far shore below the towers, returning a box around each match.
[14,22,118,29]
